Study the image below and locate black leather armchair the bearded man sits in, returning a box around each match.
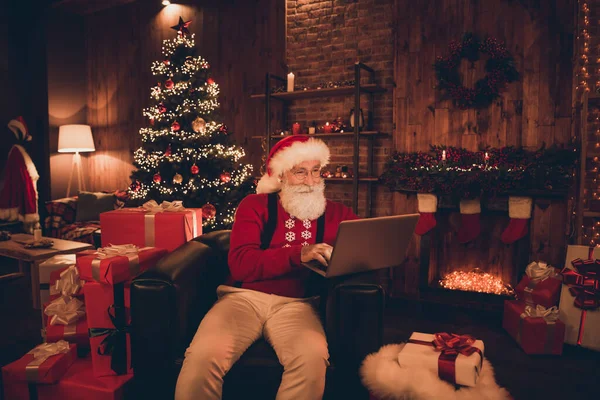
[131,231,385,400]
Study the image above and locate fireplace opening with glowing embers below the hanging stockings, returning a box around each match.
[419,198,530,310]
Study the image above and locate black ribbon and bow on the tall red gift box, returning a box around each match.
[88,283,131,375]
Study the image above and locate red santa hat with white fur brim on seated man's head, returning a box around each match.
[256,135,329,193]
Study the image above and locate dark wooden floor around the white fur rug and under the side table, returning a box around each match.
[0,259,600,400]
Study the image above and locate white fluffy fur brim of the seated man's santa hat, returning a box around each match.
[270,138,329,180]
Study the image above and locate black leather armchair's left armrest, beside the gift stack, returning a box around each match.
[131,231,228,377]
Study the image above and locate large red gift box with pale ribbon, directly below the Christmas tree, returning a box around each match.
[100,208,202,252]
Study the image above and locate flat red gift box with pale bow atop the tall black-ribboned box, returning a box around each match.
[77,246,167,285]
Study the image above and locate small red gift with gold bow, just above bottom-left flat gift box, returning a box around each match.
[43,297,90,349]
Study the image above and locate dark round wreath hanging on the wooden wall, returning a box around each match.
[434,32,519,109]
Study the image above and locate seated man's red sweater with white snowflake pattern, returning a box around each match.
[227,194,358,297]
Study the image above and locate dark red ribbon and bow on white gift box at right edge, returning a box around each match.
[561,247,600,345]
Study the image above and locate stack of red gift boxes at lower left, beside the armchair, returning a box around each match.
[2,244,167,400]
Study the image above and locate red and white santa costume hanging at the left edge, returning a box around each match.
[0,117,40,233]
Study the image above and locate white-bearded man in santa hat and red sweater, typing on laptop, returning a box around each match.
[175,135,357,400]
